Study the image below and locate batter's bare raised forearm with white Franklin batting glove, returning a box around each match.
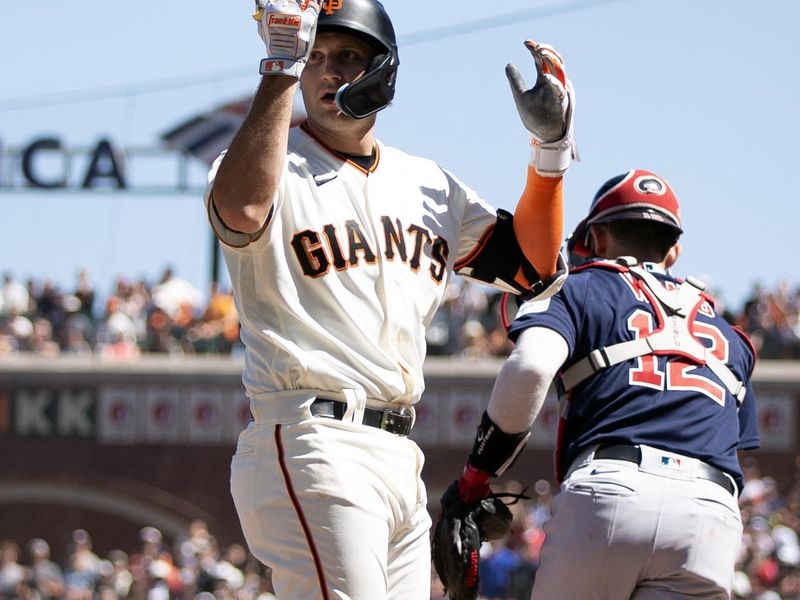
[209,0,320,234]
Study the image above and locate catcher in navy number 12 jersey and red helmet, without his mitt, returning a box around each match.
[446,169,758,600]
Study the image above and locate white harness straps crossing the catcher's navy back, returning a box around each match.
[561,257,746,404]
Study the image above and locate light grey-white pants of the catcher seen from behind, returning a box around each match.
[532,446,742,600]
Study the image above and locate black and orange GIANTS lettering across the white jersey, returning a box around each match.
[291,216,450,283]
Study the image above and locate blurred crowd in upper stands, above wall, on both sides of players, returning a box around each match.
[0,268,800,360]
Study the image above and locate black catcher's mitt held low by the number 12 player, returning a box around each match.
[431,481,512,600]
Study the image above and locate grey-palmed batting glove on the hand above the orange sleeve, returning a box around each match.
[506,40,578,177]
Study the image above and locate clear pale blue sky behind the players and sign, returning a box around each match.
[0,0,800,308]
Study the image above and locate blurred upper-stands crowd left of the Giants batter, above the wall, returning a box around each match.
[0,268,241,360]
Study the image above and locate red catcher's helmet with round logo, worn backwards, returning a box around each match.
[567,169,683,266]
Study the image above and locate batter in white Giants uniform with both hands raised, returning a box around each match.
[206,0,574,600]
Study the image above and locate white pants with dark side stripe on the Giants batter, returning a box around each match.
[231,417,431,600]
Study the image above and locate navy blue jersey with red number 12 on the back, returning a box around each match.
[509,264,759,488]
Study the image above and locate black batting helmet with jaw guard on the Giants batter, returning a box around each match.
[317,0,400,119]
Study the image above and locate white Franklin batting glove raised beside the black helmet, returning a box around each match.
[253,0,320,79]
